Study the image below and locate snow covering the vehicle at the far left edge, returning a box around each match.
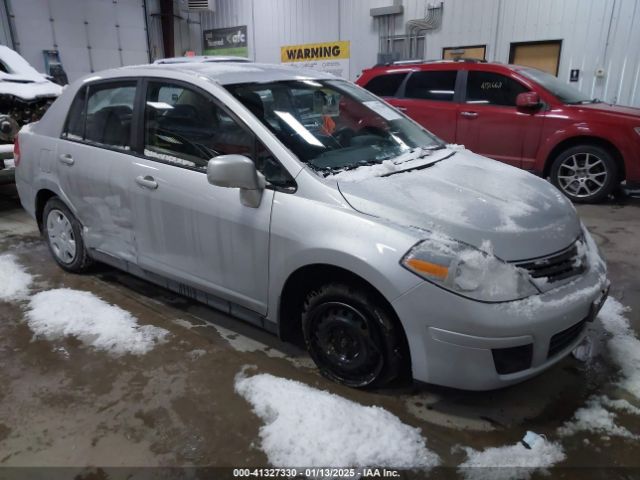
[0,45,62,100]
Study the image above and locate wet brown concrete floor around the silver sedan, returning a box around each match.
[0,187,640,478]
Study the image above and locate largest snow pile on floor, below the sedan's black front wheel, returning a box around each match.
[235,374,440,468]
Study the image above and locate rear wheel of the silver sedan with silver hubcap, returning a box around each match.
[42,197,92,273]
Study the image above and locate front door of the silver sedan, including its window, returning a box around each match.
[130,79,284,314]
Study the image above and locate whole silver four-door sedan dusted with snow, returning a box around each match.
[15,63,608,390]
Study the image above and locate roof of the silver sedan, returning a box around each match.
[110,62,338,85]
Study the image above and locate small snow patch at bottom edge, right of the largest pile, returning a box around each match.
[458,438,566,480]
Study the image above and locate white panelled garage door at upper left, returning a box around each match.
[9,0,149,81]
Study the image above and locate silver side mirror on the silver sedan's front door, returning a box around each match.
[207,155,267,208]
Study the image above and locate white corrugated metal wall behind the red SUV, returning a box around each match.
[201,0,640,106]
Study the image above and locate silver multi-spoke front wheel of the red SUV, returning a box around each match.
[550,145,619,203]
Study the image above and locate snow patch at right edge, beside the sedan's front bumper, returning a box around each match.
[598,297,640,399]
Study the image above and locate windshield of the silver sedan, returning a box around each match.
[226,80,444,174]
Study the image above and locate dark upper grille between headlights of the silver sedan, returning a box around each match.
[515,240,586,283]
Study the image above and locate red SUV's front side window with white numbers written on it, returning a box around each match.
[466,71,528,107]
